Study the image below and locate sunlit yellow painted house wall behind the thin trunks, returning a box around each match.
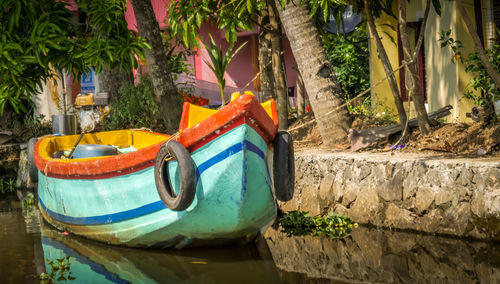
[369,0,487,122]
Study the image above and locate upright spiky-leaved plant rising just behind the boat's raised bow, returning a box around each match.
[199,34,246,105]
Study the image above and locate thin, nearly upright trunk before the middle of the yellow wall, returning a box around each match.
[399,0,430,134]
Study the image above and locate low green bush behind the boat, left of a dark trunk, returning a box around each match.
[103,77,160,130]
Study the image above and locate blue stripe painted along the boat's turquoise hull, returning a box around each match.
[38,140,265,225]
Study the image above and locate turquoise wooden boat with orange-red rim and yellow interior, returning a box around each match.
[34,93,293,248]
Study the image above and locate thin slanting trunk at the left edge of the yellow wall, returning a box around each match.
[363,0,407,125]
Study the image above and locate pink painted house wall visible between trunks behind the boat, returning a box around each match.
[125,0,296,101]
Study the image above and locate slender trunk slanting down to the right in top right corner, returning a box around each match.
[456,0,500,121]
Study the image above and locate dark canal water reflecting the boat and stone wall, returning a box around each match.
[0,201,500,283]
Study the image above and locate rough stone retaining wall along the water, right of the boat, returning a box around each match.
[279,151,500,240]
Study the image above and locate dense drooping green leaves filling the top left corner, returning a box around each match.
[0,0,148,115]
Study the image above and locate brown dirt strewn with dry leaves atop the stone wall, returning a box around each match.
[289,114,500,157]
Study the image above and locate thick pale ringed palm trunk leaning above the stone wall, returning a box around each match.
[275,0,351,146]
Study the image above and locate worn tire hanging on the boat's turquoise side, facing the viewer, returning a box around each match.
[155,140,196,211]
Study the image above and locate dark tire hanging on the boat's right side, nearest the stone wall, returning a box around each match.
[273,131,295,201]
